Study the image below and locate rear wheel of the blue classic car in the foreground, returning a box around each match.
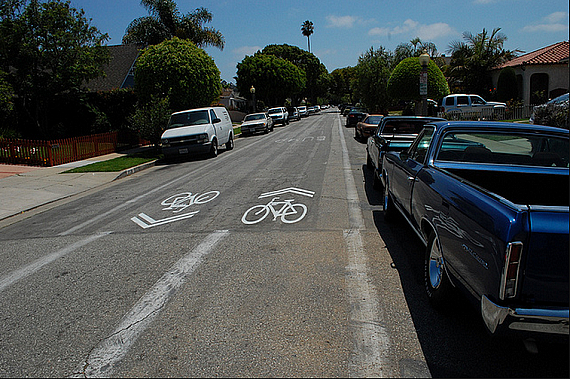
[424,232,453,309]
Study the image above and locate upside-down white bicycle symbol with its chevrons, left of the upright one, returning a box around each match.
[131,191,220,229]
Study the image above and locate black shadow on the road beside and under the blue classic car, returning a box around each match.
[362,166,569,378]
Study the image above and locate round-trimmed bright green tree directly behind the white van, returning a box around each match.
[135,37,221,111]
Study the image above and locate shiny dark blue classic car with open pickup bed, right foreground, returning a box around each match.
[381,122,569,348]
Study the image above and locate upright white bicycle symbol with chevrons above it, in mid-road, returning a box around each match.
[241,188,315,225]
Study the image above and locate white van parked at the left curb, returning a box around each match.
[160,107,234,158]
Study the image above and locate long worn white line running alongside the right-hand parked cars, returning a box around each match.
[338,119,392,378]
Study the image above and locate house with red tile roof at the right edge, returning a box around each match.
[491,41,569,105]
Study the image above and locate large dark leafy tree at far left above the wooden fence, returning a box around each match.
[0,0,109,138]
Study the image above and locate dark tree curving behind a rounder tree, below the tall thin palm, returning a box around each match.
[261,44,330,104]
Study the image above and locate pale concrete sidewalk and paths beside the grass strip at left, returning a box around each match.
[0,147,155,220]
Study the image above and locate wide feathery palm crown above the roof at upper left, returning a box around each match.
[123,0,224,50]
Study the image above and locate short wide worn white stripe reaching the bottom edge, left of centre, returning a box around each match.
[78,230,229,377]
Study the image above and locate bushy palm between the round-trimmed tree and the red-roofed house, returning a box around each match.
[448,28,516,96]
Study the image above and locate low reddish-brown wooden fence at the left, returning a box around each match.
[0,132,118,166]
